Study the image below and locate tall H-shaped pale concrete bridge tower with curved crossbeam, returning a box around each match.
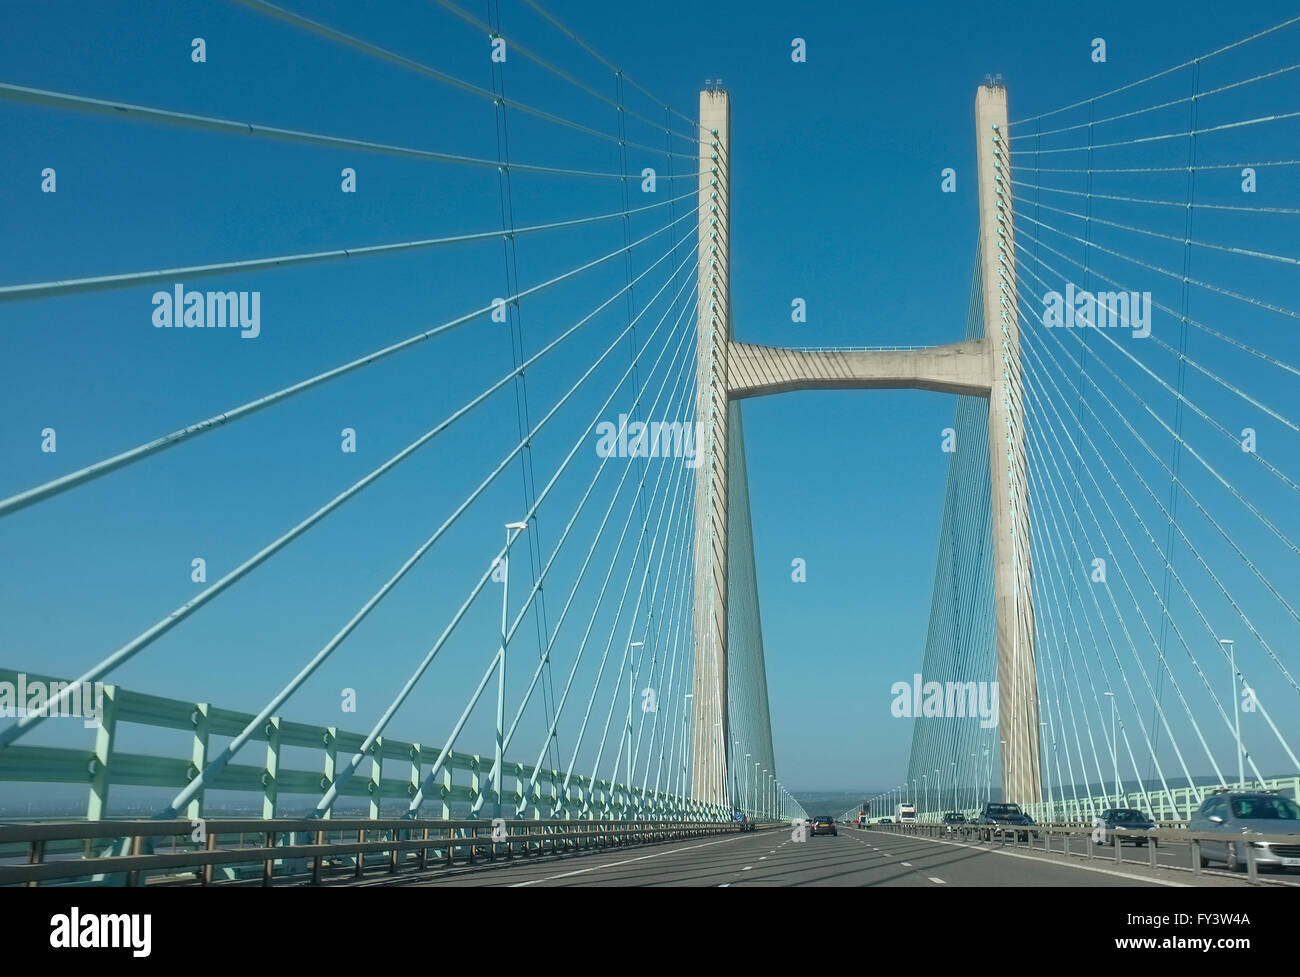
[692,86,1041,804]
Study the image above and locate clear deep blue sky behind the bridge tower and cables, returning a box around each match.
[0,0,1296,805]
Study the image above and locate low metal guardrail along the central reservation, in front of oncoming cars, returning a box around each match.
[867,821,1300,883]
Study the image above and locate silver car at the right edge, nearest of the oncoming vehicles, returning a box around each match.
[1187,790,1300,872]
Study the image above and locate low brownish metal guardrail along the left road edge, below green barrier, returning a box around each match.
[0,818,759,886]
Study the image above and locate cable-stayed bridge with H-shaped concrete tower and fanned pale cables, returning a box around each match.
[0,0,1300,881]
